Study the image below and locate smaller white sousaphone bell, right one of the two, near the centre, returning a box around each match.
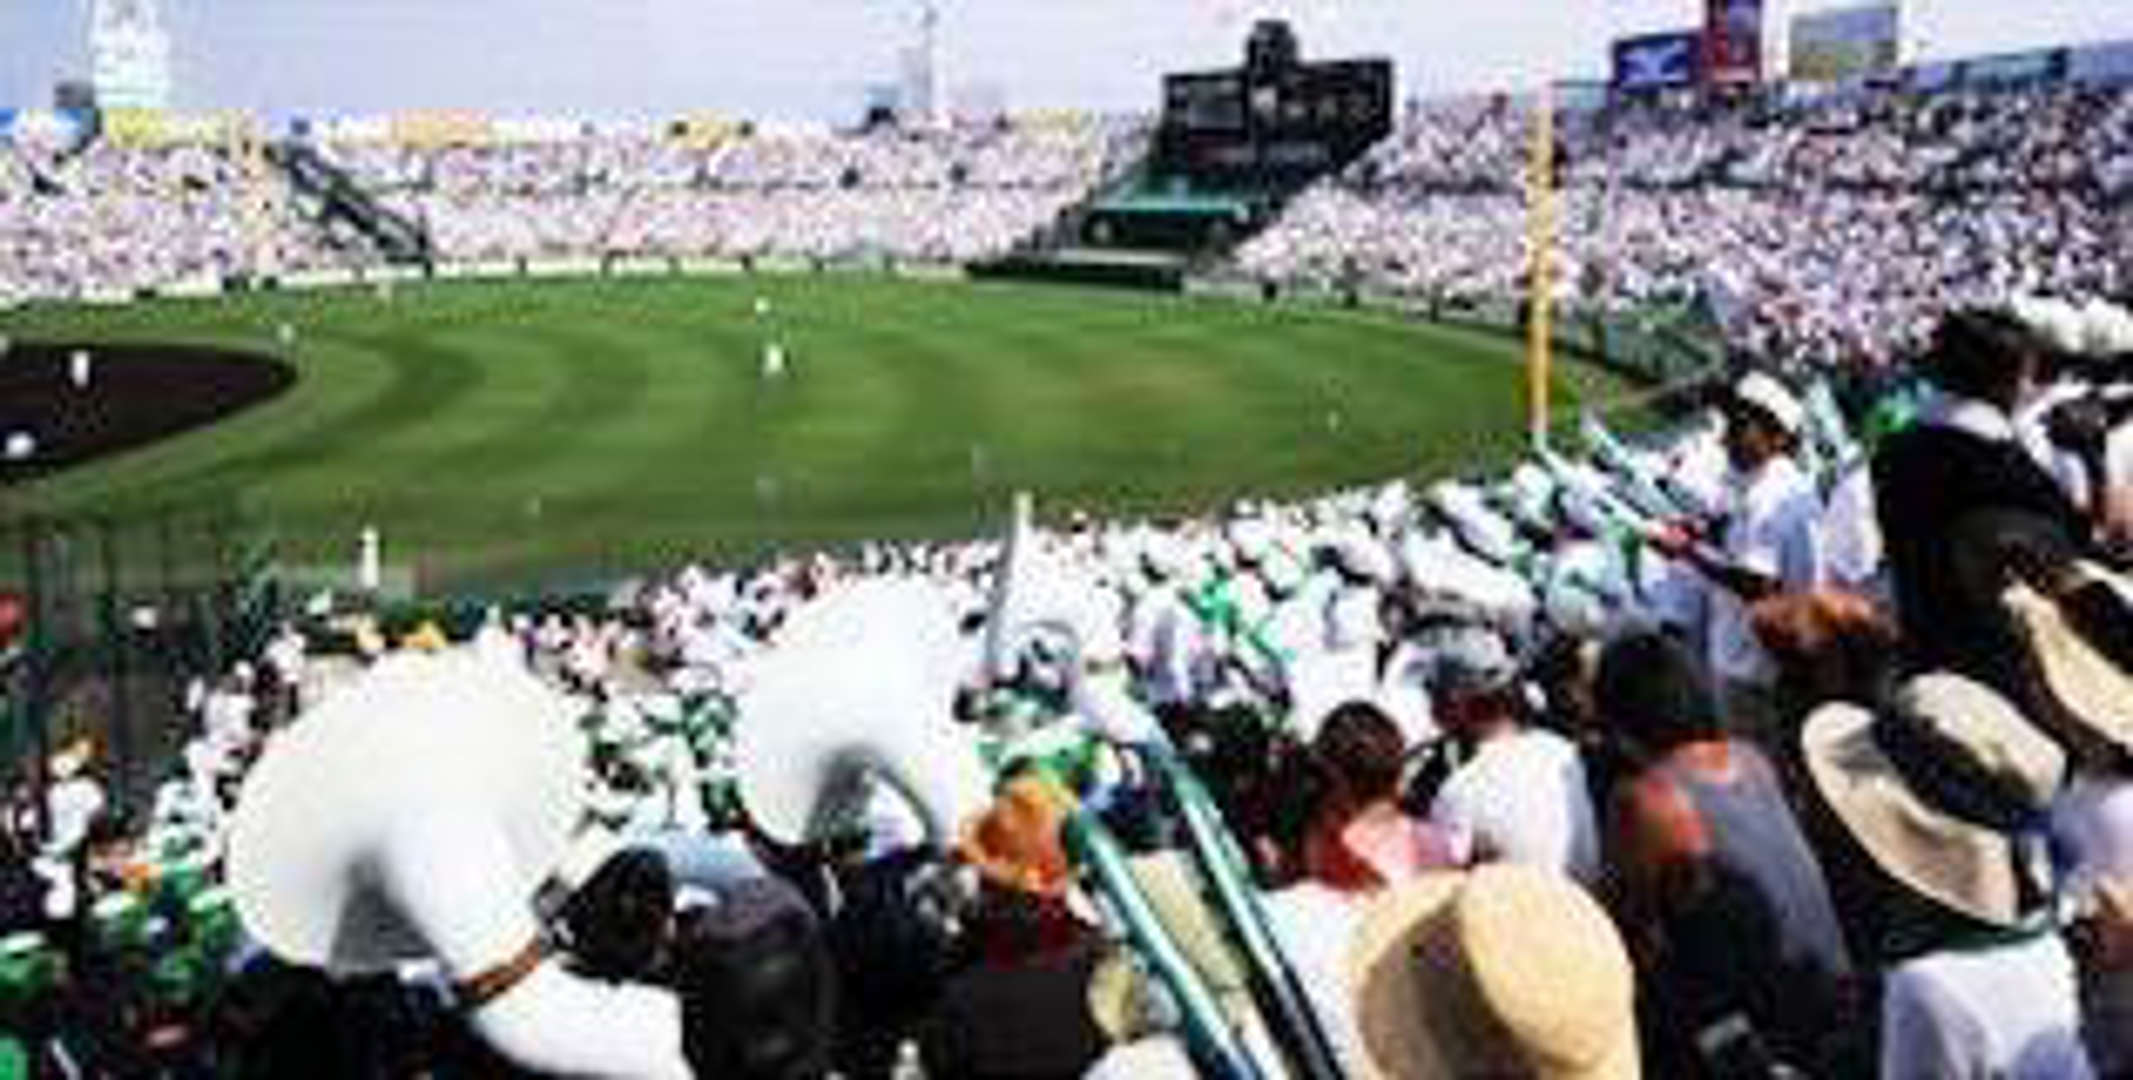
[734,578,992,847]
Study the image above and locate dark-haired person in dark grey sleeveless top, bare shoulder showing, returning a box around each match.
[1595,632,1851,1076]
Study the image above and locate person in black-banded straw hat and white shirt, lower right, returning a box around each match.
[1802,672,2090,1080]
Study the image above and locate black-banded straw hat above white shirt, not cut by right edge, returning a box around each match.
[1800,672,2065,926]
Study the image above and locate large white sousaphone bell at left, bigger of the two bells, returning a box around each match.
[228,653,580,973]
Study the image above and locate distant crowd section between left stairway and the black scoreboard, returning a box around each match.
[381,120,1137,260]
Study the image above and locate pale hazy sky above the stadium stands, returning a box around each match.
[0,0,2133,120]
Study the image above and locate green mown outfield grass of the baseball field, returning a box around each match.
[0,275,1615,589]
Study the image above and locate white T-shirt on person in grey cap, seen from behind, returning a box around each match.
[1429,730,1600,886]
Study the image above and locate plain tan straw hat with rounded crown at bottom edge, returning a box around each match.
[1348,864,1638,1080]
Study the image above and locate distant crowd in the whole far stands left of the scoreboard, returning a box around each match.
[0,117,1145,303]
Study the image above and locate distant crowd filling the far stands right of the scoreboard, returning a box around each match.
[1239,88,2133,367]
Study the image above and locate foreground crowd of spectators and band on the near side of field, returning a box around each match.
[0,299,2133,1078]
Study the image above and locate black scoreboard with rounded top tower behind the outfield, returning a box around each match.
[1156,23,1393,184]
